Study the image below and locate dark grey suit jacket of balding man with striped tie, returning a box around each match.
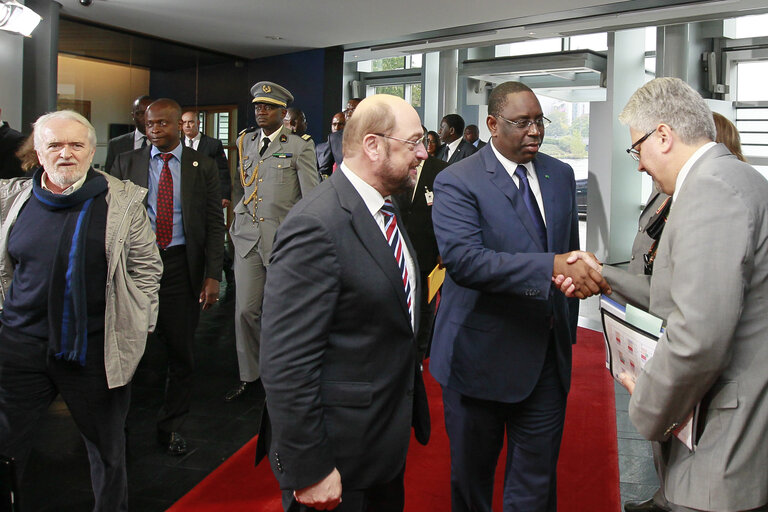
[261,172,427,490]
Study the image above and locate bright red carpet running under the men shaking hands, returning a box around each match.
[170,329,621,512]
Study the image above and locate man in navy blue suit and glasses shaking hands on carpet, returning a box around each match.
[430,82,607,512]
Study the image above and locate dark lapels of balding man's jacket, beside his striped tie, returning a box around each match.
[330,172,418,325]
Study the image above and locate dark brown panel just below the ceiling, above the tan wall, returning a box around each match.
[59,18,238,71]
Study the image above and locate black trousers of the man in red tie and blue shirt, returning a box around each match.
[155,245,200,434]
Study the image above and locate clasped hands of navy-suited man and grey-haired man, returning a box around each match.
[552,251,611,299]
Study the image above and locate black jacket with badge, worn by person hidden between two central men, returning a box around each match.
[394,157,448,273]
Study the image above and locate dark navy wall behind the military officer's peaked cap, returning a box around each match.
[150,48,343,143]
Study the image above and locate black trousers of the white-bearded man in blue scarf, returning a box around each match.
[0,327,130,512]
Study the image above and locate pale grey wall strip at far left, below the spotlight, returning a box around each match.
[0,32,24,133]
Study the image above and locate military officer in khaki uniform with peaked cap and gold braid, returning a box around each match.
[224,82,320,402]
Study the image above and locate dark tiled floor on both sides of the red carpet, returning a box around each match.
[13,284,656,512]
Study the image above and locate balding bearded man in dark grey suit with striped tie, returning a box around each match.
[261,95,427,512]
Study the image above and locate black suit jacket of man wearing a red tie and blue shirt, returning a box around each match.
[110,145,225,293]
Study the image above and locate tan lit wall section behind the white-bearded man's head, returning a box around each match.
[57,55,149,167]
